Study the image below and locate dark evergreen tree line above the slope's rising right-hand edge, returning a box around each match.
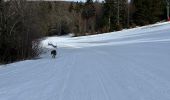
[69,0,166,36]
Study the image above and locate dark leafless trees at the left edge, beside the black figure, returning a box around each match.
[0,0,40,62]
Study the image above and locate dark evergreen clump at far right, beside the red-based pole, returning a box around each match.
[132,0,165,25]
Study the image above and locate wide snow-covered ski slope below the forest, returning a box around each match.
[0,22,170,100]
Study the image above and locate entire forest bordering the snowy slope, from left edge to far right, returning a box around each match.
[0,0,167,62]
